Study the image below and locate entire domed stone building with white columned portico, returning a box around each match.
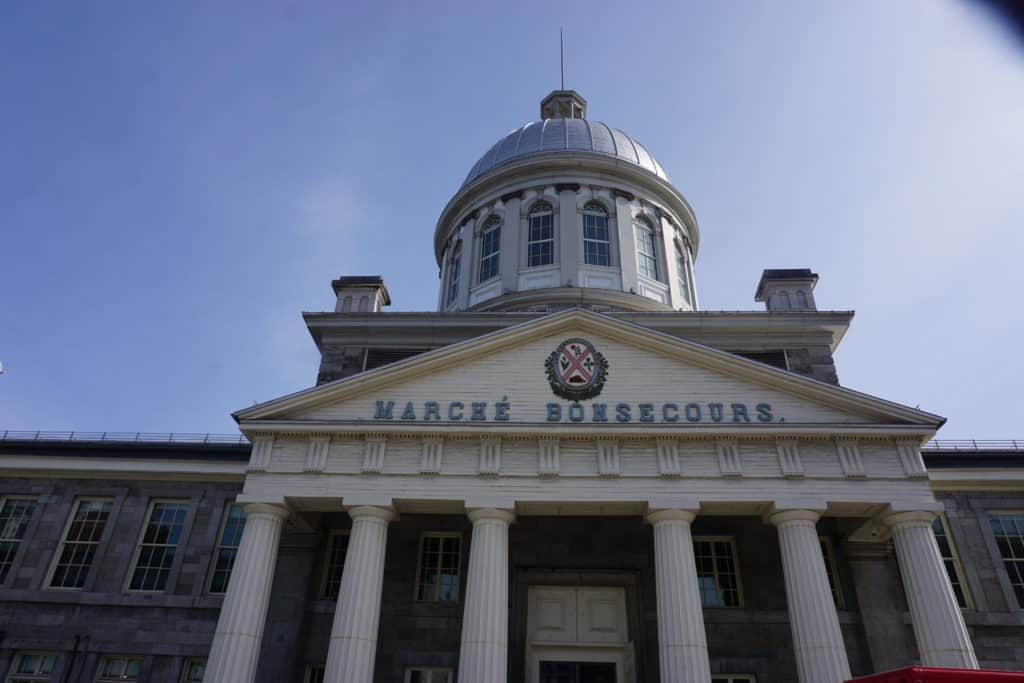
[0,91,1024,683]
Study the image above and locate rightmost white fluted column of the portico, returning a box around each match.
[885,512,978,669]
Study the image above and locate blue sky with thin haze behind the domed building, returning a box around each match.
[0,0,1024,438]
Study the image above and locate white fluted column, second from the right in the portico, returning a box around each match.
[769,510,850,683]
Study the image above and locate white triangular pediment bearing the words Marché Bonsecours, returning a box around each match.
[236,309,943,429]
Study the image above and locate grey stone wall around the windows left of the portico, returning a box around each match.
[0,479,240,683]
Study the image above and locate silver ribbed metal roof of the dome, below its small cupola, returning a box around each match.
[462,118,669,186]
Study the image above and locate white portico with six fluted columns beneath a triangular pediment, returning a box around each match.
[210,310,977,683]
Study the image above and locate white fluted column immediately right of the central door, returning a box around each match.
[647,510,711,683]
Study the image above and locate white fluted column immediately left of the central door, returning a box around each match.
[459,508,515,683]
